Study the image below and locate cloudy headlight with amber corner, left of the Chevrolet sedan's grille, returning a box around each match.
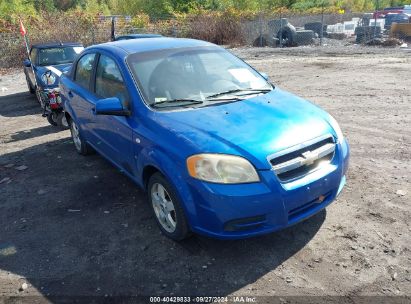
[187,154,260,184]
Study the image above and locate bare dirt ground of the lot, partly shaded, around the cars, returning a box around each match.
[0,48,411,303]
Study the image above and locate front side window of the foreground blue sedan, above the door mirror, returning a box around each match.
[96,55,129,108]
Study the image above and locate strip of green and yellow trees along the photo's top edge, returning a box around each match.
[0,0,409,21]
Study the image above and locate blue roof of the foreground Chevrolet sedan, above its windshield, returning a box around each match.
[88,37,217,55]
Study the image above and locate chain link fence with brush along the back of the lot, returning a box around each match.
[0,13,407,68]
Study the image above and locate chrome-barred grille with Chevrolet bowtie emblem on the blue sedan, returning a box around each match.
[268,135,335,181]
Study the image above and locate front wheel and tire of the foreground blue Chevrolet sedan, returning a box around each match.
[147,173,190,241]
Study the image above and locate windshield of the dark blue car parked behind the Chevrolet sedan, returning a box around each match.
[39,46,84,65]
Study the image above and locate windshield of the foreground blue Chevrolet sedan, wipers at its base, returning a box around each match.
[127,47,273,107]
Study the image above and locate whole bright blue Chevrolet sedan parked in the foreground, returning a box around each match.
[60,38,349,240]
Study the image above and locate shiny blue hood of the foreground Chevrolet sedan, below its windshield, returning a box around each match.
[159,88,335,169]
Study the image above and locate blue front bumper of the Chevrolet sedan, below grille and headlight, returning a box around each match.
[182,140,349,239]
